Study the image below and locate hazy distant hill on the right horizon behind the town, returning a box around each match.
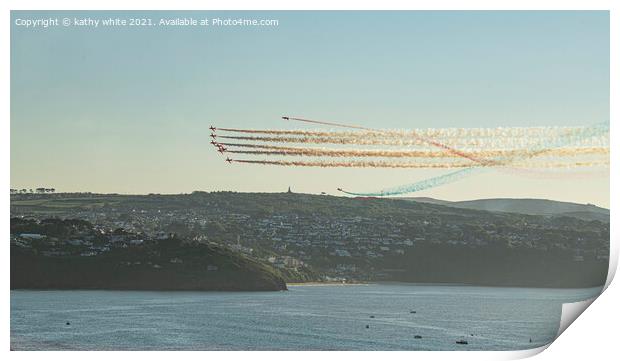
[401,197,609,222]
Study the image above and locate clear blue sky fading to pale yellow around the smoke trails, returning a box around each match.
[11,11,609,207]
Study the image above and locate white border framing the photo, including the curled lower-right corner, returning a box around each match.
[0,0,619,360]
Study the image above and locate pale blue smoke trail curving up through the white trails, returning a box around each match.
[341,123,609,197]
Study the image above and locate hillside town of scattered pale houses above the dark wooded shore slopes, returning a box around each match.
[11,194,609,280]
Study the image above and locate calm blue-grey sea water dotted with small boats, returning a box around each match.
[11,284,600,350]
